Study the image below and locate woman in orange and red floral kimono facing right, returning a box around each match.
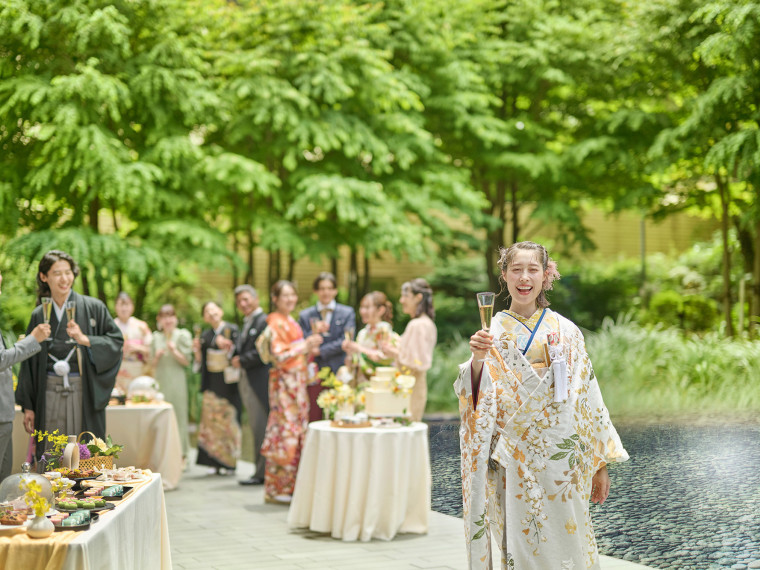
[261,280,322,503]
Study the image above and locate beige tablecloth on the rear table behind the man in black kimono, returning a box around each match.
[13,402,182,491]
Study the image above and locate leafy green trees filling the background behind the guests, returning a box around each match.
[0,0,760,418]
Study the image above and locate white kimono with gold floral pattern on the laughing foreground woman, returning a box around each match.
[454,309,628,570]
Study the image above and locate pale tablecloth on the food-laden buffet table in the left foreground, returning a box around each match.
[0,474,172,570]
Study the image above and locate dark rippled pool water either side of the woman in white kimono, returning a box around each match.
[429,422,760,570]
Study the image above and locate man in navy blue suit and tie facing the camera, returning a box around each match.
[298,272,356,422]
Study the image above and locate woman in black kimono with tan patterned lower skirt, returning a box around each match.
[193,301,242,475]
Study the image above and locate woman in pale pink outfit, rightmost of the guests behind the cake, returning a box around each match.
[381,278,438,422]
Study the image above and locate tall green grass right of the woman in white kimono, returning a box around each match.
[586,312,760,415]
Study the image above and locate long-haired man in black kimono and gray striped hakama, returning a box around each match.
[16,250,124,452]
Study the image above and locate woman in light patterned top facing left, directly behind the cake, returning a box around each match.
[342,291,399,384]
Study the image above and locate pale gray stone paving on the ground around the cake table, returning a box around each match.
[166,452,646,570]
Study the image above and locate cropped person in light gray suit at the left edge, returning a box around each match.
[0,273,50,481]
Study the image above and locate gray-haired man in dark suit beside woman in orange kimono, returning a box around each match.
[232,285,269,485]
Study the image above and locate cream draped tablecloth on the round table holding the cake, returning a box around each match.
[288,421,431,541]
